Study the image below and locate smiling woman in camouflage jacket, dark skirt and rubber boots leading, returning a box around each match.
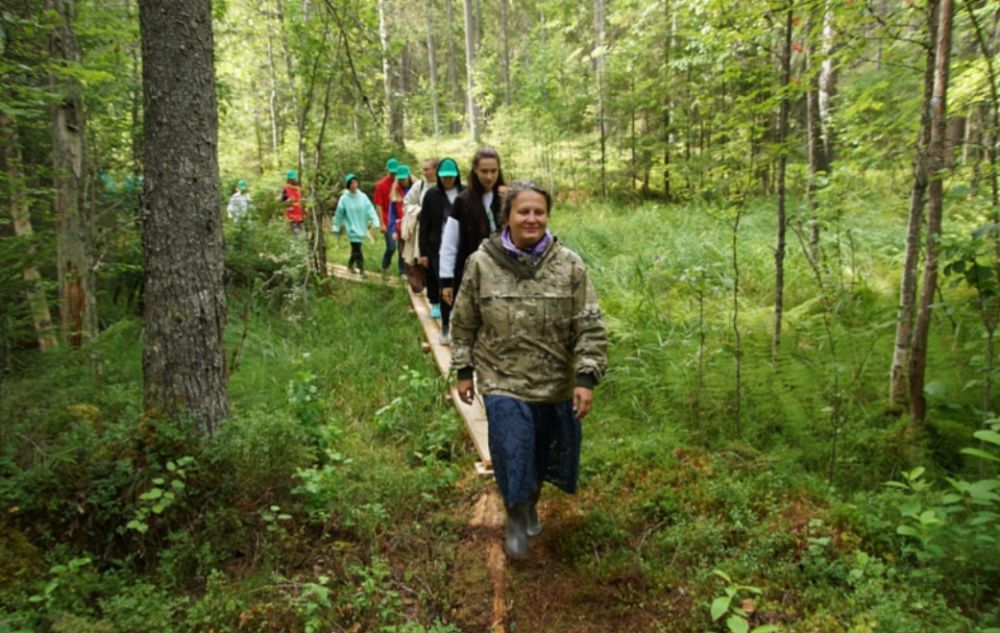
[451,182,607,557]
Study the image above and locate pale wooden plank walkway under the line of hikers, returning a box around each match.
[328,264,493,475]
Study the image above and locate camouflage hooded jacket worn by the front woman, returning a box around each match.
[451,236,607,402]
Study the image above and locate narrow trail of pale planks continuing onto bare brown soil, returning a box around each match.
[328,265,672,633]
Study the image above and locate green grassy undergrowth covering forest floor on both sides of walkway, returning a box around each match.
[0,189,1000,633]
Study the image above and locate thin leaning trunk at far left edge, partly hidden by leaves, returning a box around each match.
[0,111,59,351]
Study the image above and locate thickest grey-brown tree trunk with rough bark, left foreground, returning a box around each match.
[139,0,229,433]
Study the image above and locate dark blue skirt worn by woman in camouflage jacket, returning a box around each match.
[483,395,582,508]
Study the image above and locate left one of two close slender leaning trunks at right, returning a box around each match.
[889,0,940,407]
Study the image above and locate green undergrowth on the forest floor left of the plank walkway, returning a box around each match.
[0,229,475,633]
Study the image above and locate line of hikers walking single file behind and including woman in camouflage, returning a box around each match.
[226,147,607,558]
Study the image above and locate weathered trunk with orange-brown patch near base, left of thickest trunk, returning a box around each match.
[45,0,97,347]
